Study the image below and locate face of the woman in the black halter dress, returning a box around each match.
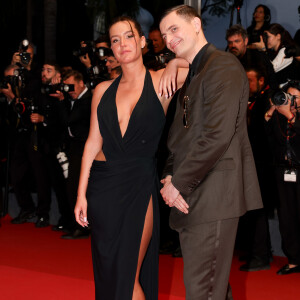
[109,21,146,64]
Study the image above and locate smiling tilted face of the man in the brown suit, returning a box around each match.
[160,11,200,61]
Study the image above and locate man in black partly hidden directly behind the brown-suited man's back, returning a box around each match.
[237,67,276,272]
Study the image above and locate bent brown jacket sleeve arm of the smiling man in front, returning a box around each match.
[172,56,249,195]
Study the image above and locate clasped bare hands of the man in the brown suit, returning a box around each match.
[160,176,189,214]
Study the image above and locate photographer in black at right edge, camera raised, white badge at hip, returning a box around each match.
[265,80,300,275]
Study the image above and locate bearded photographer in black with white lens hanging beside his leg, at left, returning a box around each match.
[41,61,72,231]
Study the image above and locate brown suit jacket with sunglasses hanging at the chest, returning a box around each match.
[164,45,262,229]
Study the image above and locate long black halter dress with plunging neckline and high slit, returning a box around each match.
[87,70,165,300]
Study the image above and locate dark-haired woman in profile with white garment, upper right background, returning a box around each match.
[255,23,300,89]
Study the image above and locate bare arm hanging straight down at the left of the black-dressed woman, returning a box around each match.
[74,81,112,227]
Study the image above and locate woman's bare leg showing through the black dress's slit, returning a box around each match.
[132,196,153,300]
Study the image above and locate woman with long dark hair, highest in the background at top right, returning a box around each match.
[247,4,271,49]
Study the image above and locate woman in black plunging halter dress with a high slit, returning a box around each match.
[75,17,187,300]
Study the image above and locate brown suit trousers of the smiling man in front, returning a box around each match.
[179,218,239,300]
